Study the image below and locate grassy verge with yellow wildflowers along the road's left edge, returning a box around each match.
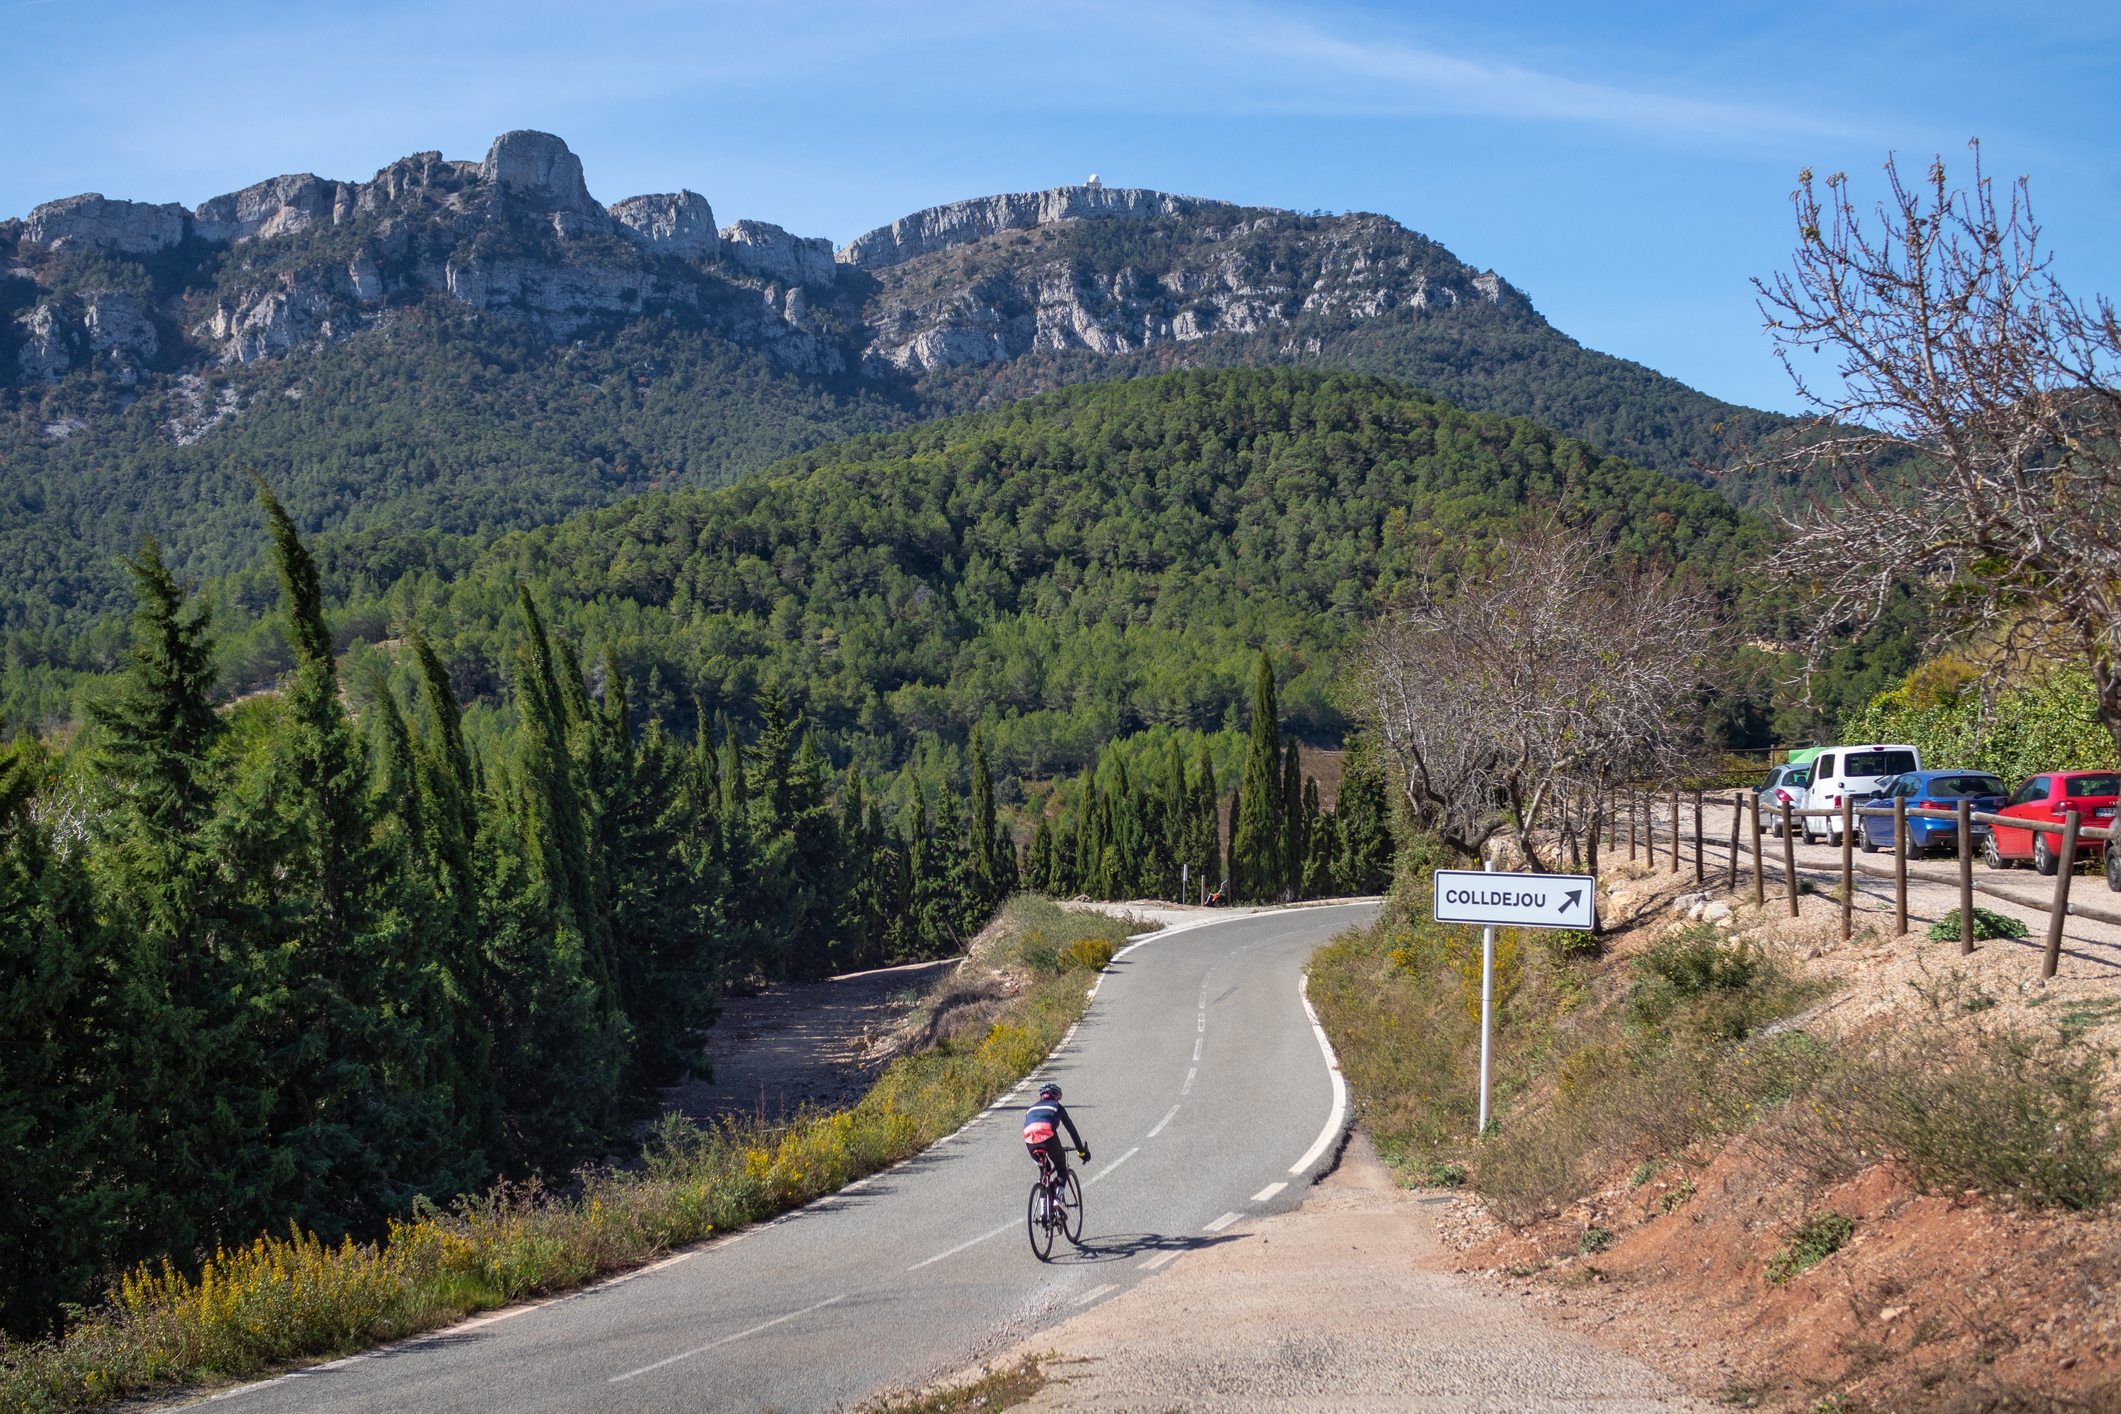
[0,903,1111,1412]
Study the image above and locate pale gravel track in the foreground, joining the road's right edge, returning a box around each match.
[979,1134,1714,1414]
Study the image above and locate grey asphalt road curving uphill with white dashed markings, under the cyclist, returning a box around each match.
[223,903,1374,1414]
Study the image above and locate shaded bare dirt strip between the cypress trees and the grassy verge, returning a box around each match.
[664,958,957,1121]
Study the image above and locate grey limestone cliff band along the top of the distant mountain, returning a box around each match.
[8,131,1536,396]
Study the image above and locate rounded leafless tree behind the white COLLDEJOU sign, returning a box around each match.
[1355,522,1718,869]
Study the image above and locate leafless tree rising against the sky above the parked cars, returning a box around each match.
[1752,144,2121,748]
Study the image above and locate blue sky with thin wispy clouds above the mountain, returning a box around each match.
[0,0,2121,407]
